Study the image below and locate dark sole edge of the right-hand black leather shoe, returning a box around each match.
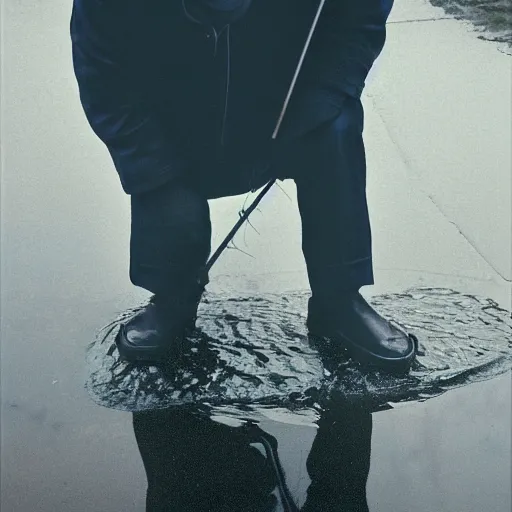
[309,330,418,374]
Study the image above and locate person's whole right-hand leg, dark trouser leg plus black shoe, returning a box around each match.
[290,97,416,372]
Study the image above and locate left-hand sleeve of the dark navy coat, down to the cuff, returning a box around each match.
[70,0,186,194]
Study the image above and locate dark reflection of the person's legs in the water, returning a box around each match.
[133,405,372,512]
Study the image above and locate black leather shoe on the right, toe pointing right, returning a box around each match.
[307,292,418,373]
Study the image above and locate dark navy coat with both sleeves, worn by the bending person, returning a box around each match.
[71,0,393,194]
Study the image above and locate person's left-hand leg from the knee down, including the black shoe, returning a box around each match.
[116,182,211,363]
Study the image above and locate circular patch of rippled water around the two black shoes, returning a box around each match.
[86,288,512,412]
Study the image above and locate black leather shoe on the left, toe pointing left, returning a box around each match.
[116,293,201,364]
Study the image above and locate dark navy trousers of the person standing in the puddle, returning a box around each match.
[130,97,373,297]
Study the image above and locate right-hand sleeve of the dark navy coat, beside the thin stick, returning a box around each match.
[304,0,393,102]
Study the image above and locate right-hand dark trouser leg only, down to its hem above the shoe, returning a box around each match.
[295,97,373,300]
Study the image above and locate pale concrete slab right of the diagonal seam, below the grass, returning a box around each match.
[374,0,512,281]
